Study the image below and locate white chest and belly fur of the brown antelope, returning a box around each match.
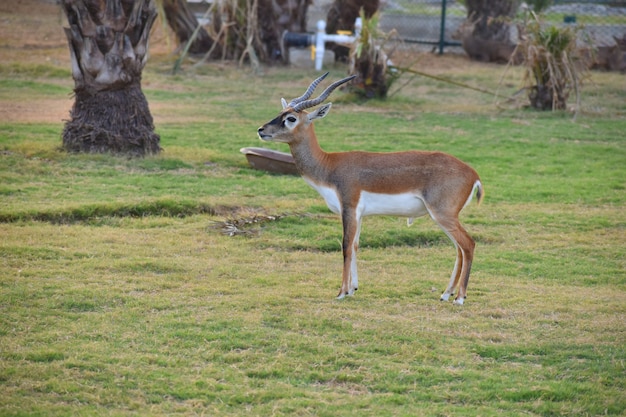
[304,177,428,217]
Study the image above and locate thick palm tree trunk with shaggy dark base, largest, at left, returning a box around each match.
[61,0,161,156]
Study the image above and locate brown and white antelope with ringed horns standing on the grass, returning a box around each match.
[258,73,483,304]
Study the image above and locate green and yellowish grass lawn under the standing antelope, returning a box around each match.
[0,56,626,416]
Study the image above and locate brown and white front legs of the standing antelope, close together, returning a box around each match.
[337,206,361,299]
